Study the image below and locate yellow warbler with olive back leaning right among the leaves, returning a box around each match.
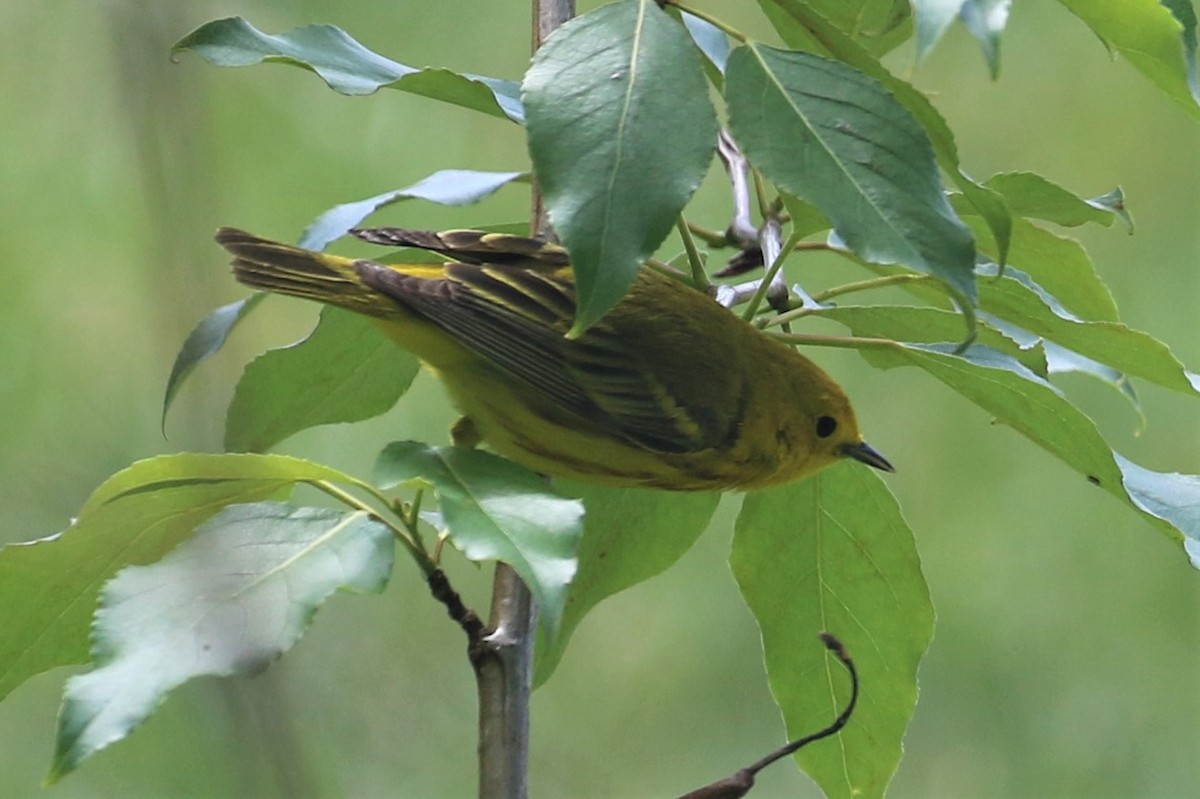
[216,228,892,491]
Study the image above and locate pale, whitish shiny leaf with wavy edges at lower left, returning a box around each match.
[48,503,394,781]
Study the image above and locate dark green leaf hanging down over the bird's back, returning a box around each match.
[522,0,716,336]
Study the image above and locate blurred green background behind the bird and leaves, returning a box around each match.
[0,0,1200,799]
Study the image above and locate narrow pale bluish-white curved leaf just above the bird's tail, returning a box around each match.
[300,169,528,250]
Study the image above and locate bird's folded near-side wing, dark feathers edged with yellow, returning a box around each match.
[355,262,730,452]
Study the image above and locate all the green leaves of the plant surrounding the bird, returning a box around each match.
[0,0,1200,797]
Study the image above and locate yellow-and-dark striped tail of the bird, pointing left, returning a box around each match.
[216,228,390,316]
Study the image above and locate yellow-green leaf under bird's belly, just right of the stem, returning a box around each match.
[534,480,720,685]
